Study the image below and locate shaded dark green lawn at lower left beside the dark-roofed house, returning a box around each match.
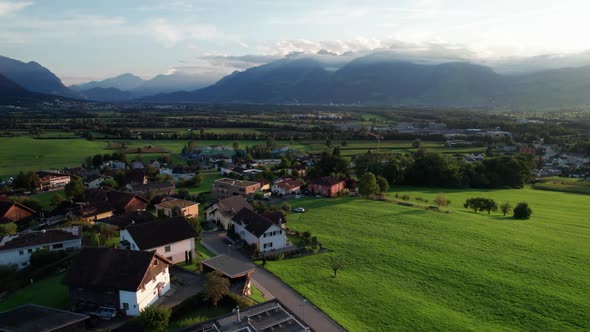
[0,274,69,311]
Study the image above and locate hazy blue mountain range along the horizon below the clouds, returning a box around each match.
[0,52,590,109]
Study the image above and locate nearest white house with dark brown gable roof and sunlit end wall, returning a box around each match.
[63,248,171,316]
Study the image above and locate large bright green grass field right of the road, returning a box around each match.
[267,188,590,331]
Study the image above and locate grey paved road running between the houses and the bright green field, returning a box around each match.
[201,232,345,332]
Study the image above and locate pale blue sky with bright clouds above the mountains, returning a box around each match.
[0,0,590,84]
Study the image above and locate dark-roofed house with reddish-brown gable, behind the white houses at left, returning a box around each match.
[84,189,148,213]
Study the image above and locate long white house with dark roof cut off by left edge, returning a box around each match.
[0,226,82,270]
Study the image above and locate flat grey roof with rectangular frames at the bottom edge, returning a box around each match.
[179,299,313,332]
